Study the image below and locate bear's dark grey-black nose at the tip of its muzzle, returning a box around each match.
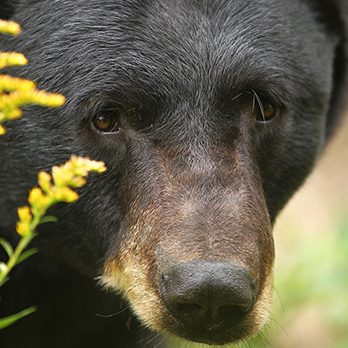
[160,260,255,329]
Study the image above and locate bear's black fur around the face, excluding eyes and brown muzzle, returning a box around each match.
[0,0,347,348]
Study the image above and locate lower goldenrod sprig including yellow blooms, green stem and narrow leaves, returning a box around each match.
[0,156,106,330]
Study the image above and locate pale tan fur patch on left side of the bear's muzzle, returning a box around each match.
[100,218,166,331]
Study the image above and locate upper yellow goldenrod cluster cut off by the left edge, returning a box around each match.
[0,20,65,135]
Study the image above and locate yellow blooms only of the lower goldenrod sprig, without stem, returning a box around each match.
[17,156,106,236]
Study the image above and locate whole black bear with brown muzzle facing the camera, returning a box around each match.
[0,0,346,348]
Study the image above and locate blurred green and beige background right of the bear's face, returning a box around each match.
[243,117,348,348]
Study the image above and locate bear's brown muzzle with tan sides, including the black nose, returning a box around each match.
[102,141,274,345]
